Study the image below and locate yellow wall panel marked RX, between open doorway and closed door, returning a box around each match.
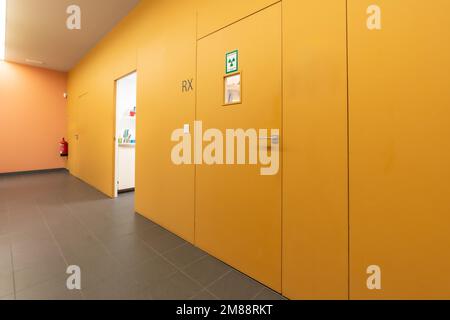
[136,1,196,242]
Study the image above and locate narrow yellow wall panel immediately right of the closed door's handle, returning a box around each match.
[283,0,348,299]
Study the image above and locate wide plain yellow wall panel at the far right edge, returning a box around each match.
[349,0,450,299]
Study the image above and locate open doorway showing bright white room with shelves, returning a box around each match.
[115,72,137,197]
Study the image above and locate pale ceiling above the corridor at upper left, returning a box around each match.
[6,0,139,71]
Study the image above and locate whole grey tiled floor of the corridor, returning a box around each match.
[0,172,283,300]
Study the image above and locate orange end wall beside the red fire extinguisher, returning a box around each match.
[0,62,67,173]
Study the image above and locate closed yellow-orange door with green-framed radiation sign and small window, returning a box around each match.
[195,4,282,291]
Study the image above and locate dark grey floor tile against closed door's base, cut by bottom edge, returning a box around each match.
[208,271,264,300]
